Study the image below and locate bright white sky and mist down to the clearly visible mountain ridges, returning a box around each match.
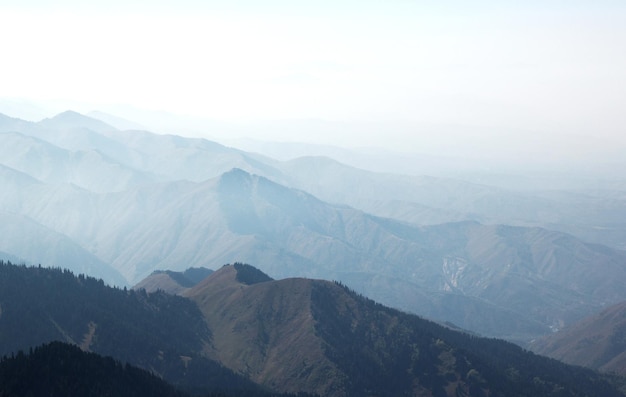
[0,1,626,176]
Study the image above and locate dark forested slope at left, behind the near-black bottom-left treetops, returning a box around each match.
[0,261,258,392]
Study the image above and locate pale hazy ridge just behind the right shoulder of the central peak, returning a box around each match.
[282,157,557,224]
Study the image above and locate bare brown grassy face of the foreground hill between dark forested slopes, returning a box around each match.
[184,266,339,395]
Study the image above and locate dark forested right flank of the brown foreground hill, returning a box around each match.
[312,283,623,397]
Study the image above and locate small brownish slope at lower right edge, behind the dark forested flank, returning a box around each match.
[530,302,626,375]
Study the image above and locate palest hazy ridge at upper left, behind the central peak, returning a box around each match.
[0,111,284,192]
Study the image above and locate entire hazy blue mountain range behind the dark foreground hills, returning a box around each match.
[0,112,626,343]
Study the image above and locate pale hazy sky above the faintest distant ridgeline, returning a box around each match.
[0,0,626,152]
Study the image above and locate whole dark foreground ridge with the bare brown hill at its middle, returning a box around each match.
[0,263,623,397]
